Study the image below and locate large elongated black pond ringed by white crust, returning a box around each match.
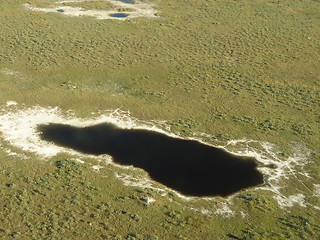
[38,123,263,196]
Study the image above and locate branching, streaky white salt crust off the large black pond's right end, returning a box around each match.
[226,140,311,212]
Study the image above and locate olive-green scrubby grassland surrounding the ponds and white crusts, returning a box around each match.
[0,0,320,239]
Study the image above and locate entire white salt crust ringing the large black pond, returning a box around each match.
[0,101,320,217]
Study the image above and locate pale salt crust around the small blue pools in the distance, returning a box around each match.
[24,0,157,21]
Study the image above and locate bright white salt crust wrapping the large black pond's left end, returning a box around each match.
[0,101,172,159]
